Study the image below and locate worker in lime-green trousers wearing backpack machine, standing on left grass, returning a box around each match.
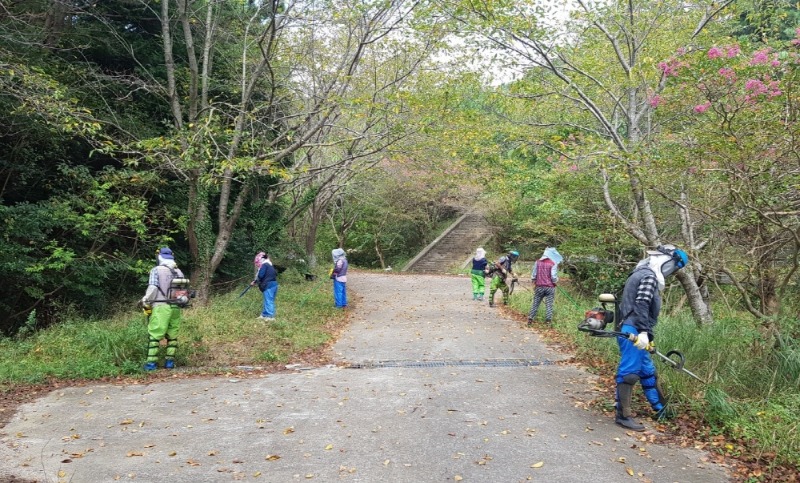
[139,247,195,371]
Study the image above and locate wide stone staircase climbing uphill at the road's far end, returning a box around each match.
[402,213,492,273]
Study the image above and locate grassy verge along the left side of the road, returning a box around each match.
[0,270,343,388]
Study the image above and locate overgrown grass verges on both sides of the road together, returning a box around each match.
[0,271,800,470]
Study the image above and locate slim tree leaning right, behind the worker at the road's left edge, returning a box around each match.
[288,24,440,267]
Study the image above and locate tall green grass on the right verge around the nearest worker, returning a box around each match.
[511,280,800,471]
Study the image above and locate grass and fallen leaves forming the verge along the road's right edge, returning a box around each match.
[504,264,800,481]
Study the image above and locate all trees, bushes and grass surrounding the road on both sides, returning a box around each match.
[0,0,800,481]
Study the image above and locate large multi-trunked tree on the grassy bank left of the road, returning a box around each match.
[122,0,422,300]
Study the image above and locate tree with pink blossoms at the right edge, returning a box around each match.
[658,35,800,328]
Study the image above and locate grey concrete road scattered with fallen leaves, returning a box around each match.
[0,272,728,483]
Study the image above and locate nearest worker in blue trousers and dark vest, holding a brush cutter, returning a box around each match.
[578,245,699,431]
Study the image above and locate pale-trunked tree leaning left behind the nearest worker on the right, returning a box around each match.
[438,0,733,322]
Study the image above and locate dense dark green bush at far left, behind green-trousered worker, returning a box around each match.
[0,164,173,333]
